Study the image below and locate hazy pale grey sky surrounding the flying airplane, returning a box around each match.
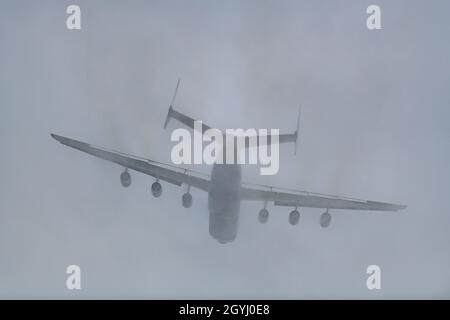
[0,0,450,298]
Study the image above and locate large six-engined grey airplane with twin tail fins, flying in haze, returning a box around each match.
[51,82,406,244]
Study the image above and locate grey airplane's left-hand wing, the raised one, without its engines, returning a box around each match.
[51,134,210,191]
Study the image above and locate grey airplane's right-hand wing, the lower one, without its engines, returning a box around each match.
[241,185,406,211]
